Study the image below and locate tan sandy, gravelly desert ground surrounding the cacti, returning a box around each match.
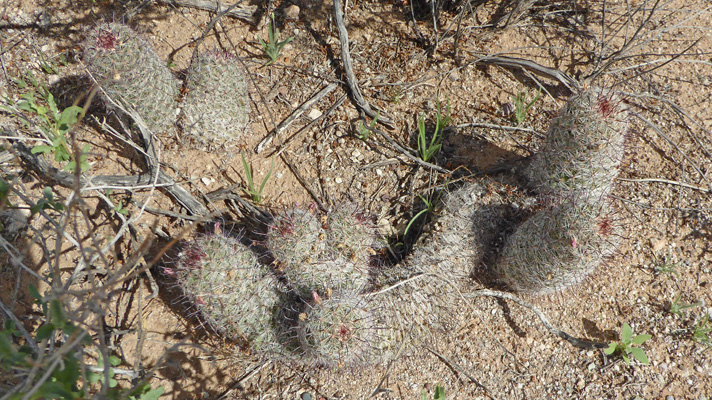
[0,0,712,399]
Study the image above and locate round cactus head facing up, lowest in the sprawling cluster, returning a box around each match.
[297,292,378,367]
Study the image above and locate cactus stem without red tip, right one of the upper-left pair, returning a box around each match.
[180,50,250,146]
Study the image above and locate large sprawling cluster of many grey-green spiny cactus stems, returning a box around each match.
[168,90,625,367]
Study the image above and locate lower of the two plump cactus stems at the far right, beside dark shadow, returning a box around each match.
[496,197,618,294]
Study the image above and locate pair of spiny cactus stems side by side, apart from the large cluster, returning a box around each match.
[84,22,250,146]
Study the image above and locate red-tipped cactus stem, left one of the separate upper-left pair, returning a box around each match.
[84,23,180,133]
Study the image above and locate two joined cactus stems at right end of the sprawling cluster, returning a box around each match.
[495,88,627,294]
